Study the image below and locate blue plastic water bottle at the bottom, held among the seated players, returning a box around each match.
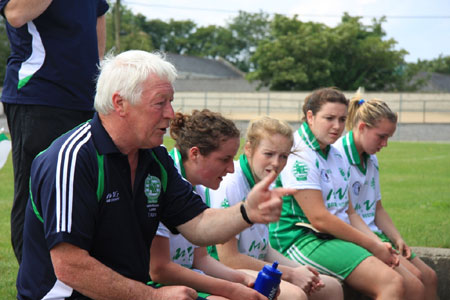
[254,261,281,300]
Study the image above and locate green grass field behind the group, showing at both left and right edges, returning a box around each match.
[0,141,450,299]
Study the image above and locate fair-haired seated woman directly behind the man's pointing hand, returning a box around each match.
[210,117,343,300]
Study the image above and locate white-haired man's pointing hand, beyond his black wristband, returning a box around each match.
[245,171,297,224]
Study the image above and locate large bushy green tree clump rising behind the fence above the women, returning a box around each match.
[248,13,414,90]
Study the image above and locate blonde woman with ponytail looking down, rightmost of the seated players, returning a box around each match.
[335,93,437,299]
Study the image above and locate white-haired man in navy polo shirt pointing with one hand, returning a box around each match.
[17,50,293,300]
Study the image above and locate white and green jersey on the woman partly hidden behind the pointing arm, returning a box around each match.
[210,154,269,260]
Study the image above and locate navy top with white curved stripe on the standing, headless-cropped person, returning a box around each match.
[0,0,108,111]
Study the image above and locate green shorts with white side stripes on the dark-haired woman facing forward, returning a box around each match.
[284,233,372,280]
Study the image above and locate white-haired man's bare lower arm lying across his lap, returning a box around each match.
[50,243,197,300]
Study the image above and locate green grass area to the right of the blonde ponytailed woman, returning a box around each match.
[378,142,450,248]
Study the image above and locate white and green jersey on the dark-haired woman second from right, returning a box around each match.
[280,122,350,223]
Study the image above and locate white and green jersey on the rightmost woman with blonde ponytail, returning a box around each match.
[334,131,381,233]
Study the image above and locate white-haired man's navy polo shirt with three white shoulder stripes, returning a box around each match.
[17,114,207,299]
